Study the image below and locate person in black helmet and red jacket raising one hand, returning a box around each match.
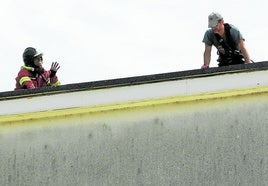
[15,47,60,90]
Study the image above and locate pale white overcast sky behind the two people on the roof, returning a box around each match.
[0,0,268,92]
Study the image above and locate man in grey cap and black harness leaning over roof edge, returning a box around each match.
[201,12,251,68]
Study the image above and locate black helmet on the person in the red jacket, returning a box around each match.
[22,47,43,67]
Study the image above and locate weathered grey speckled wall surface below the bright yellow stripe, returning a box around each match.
[0,93,268,186]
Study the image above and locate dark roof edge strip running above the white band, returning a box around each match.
[0,61,268,100]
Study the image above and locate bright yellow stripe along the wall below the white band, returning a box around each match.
[0,86,268,125]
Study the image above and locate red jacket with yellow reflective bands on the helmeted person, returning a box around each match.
[15,66,60,90]
